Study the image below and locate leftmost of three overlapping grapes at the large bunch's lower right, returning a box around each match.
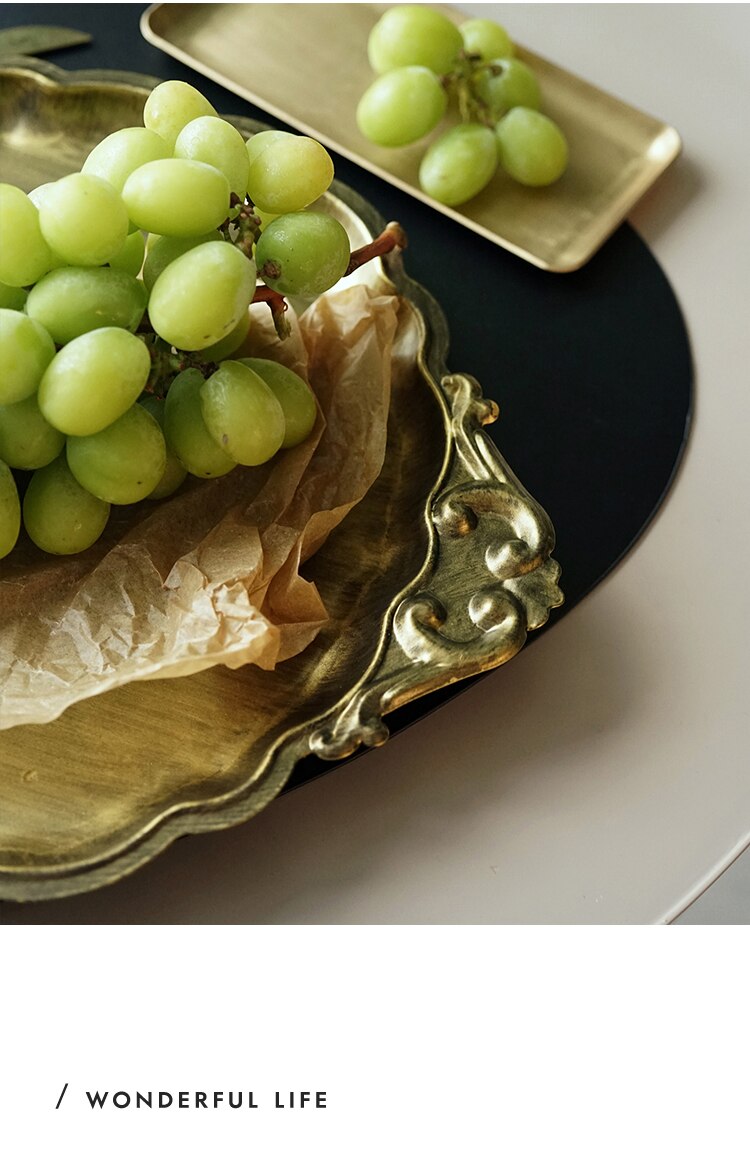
[164,367,237,479]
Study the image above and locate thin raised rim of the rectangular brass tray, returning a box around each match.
[141,3,682,274]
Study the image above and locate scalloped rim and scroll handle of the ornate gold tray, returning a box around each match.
[0,56,562,901]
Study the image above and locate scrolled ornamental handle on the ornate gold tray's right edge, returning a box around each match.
[310,376,562,759]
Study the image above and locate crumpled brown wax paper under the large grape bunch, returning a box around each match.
[0,285,408,728]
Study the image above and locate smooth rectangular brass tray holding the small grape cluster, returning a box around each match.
[141,3,681,272]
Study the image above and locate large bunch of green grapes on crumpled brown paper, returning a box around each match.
[0,81,351,558]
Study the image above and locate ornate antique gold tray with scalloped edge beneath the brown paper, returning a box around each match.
[0,59,561,900]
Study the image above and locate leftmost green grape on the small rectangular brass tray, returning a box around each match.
[357,65,448,147]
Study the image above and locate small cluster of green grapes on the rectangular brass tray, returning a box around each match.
[357,5,568,207]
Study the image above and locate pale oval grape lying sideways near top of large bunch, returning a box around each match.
[122,157,229,236]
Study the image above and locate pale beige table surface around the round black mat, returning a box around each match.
[0,3,750,924]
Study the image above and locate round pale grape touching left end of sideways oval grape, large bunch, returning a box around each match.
[39,172,129,265]
